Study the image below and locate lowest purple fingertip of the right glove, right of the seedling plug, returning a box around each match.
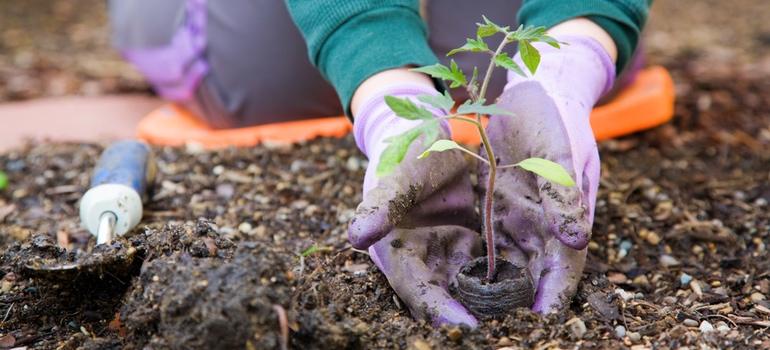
[529,239,587,314]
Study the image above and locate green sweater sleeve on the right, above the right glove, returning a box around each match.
[518,0,652,74]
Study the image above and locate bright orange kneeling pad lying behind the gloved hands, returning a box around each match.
[137,66,674,148]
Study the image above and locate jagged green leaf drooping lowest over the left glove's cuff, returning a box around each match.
[376,119,439,177]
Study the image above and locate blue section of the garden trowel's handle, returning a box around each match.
[91,141,152,197]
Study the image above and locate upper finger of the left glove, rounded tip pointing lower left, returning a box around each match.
[348,149,468,249]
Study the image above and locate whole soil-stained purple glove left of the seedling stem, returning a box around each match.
[348,85,481,327]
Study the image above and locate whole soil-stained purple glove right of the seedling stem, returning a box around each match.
[479,36,615,313]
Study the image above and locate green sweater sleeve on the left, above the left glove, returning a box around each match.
[286,0,438,115]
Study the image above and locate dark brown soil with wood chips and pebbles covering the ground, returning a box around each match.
[0,0,770,350]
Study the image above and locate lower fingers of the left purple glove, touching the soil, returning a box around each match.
[369,226,480,327]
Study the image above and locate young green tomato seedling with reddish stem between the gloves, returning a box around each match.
[377,17,575,281]
